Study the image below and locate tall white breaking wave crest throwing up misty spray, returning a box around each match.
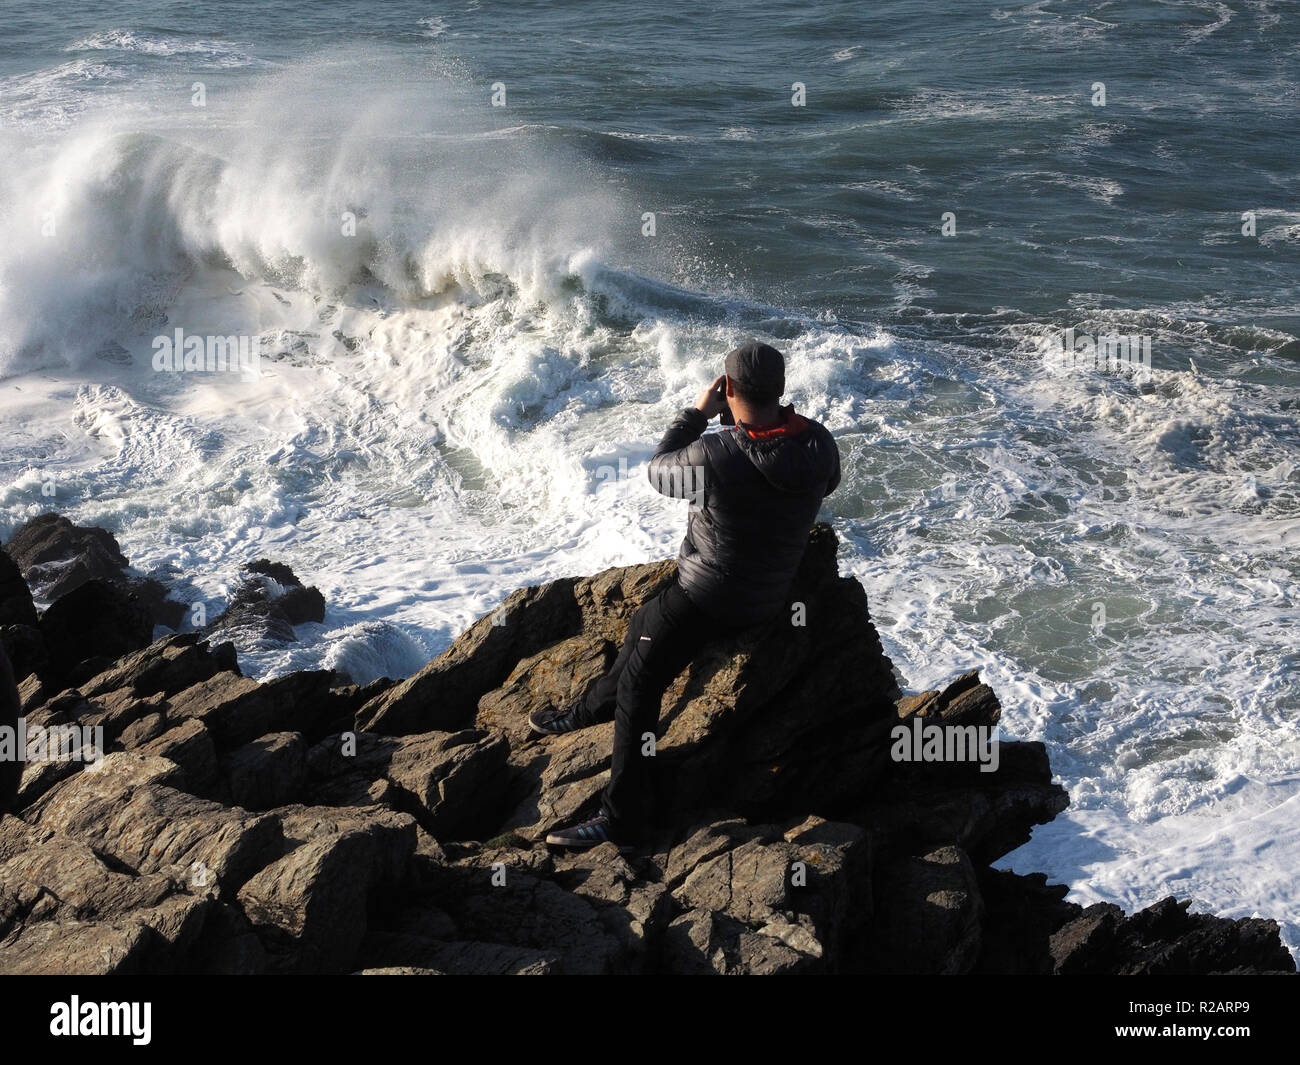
[0,52,634,373]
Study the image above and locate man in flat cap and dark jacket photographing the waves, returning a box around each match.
[529,343,840,853]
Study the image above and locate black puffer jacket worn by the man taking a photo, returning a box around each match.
[650,407,840,624]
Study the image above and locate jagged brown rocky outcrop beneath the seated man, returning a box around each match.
[0,523,1295,974]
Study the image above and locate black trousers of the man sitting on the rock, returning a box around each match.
[584,579,742,843]
